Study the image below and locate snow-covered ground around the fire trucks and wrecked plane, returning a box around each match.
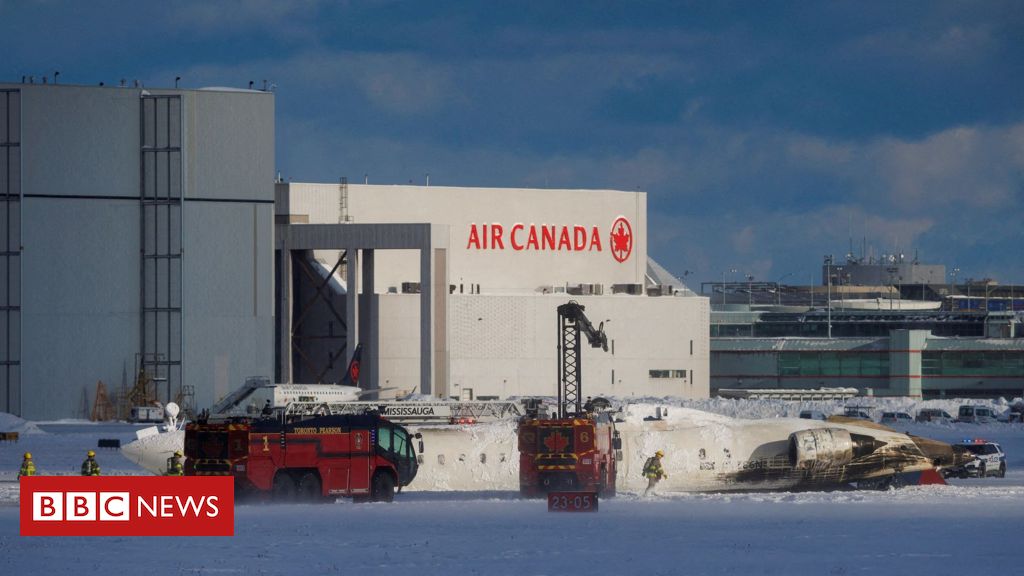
[0,399,1024,576]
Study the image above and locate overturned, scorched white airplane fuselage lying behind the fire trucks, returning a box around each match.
[122,405,972,492]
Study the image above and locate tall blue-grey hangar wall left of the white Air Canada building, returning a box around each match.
[0,84,273,419]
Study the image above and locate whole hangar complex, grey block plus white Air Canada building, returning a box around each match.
[0,83,710,419]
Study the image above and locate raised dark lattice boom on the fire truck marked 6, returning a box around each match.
[558,300,608,418]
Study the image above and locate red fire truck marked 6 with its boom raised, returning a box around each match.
[518,301,622,497]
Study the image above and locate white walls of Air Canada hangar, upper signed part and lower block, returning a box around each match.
[276,182,710,398]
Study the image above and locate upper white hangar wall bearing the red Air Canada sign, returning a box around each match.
[278,182,647,293]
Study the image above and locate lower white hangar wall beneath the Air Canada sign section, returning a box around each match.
[378,294,710,399]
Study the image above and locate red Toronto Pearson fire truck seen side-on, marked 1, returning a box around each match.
[184,410,423,501]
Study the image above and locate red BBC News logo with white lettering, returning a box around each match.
[20,477,234,536]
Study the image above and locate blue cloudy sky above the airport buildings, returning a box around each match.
[0,0,1024,290]
